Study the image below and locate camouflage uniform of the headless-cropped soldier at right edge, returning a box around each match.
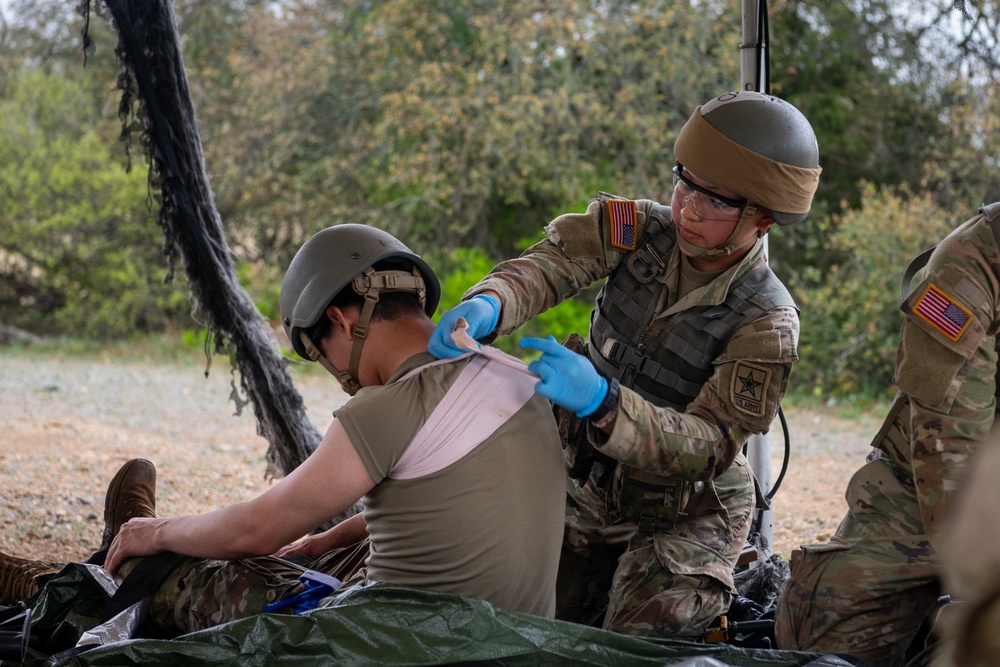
[776,204,1000,665]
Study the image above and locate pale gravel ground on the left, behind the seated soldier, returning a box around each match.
[0,348,346,561]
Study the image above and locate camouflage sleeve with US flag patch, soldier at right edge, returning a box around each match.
[896,217,1000,541]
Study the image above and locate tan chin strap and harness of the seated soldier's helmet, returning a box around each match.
[299,267,427,396]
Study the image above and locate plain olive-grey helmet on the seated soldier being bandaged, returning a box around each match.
[280,224,441,359]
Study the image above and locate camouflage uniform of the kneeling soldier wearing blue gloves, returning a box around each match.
[463,194,798,637]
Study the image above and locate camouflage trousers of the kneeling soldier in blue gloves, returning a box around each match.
[556,456,754,638]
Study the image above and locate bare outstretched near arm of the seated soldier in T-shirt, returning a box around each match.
[105,421,375,572]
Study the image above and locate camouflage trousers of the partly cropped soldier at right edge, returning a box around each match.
[775,459,941,666]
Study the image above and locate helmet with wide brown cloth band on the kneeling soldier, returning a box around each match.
[674,91,821,225]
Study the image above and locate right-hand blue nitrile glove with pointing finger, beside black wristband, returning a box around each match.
[521,336,608,417]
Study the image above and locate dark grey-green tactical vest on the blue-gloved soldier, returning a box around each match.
[570,205,795,532]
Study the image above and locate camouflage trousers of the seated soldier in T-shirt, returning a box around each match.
[120,539,368,636]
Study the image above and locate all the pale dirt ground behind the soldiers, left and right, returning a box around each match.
[0,348,881,562]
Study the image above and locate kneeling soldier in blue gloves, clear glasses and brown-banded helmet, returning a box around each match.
[430,92,820,637]
